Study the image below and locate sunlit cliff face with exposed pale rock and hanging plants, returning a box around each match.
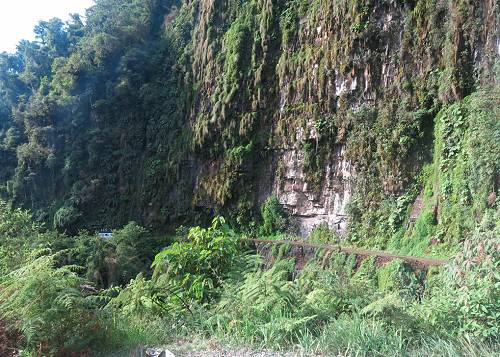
[182,1,499,233]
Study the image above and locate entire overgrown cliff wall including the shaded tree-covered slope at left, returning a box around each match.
[0,0,500,239]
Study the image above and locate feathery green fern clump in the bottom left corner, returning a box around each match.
[0,251,106,354]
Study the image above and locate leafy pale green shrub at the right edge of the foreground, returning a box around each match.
[419,212,500,340]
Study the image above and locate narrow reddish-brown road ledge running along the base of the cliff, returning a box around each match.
[242,238,448,268]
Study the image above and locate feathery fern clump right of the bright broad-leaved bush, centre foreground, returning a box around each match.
[205,259,306,347]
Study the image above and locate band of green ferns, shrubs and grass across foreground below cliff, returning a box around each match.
[0,197,500,356]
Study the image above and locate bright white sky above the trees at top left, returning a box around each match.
[0,0,94,52]
